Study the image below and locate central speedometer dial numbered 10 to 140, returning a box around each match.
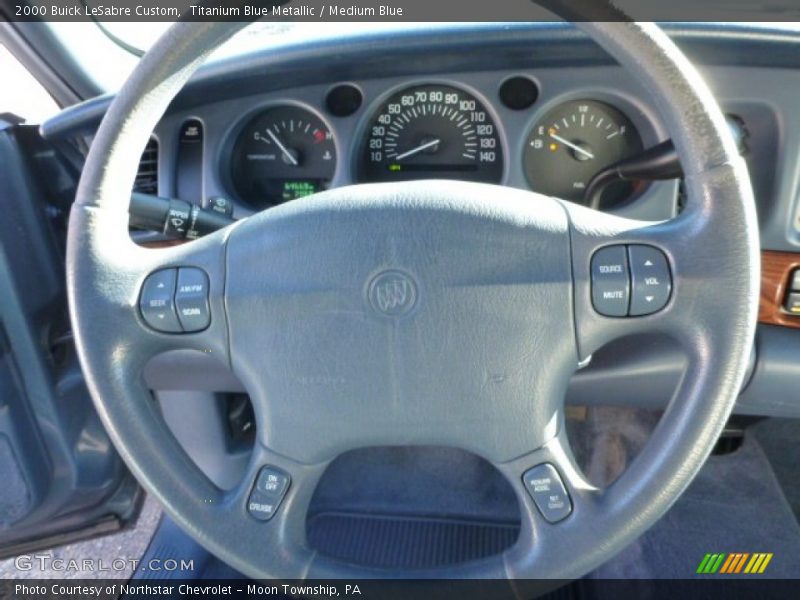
[358,85,503,183]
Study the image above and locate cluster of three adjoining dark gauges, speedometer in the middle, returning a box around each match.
[222,75,656,210]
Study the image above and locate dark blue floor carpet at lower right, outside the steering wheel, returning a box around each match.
[592,435,800,579]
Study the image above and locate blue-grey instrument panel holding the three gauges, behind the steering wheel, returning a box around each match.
[156,66,678,220]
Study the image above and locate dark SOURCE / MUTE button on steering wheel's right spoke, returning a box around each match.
[591,246,630,317]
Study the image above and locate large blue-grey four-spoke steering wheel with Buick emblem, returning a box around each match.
[67,22,759,579]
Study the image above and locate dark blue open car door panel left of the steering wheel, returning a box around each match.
[0,125,141,556]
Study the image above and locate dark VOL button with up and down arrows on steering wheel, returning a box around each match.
[628,245,672,317]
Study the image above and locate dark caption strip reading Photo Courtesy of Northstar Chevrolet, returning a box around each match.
[0,574,800,600]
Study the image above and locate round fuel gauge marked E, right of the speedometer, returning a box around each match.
[523,100,642,206]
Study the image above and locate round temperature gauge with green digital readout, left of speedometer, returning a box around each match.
[232,105,336,208]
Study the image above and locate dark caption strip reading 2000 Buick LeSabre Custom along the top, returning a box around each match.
[0,0,800,22]
